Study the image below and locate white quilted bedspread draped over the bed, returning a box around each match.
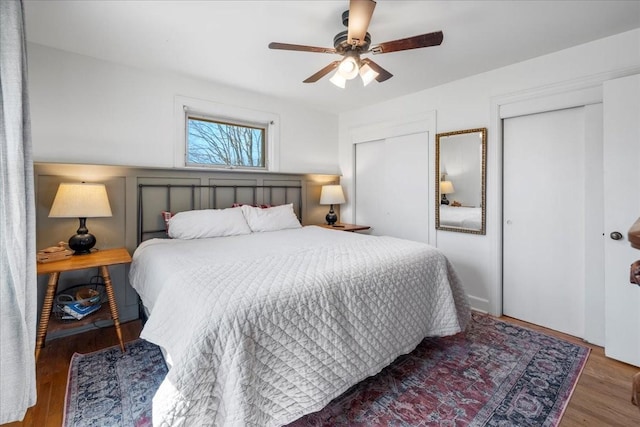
[130,227,470,427]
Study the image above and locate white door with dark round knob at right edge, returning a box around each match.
[604,75,640,366]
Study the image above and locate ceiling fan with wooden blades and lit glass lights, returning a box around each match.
[269,0,444,88]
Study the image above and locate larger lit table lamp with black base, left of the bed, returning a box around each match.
[49,182,111,255]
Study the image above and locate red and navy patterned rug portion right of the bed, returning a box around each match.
[289,313,589,427]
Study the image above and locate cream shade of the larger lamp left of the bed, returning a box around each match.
[49,183,112,218]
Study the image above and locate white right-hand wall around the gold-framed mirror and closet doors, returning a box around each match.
[339,29,640,314]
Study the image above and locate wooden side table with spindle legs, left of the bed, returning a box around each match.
[36,248,131,361]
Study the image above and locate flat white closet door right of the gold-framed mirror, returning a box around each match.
[503,107,587,337]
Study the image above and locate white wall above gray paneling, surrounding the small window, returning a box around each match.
[27,44,338,174]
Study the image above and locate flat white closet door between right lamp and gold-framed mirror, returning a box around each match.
[355,132,431,243]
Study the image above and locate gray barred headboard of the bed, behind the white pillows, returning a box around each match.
[138,184,303,244]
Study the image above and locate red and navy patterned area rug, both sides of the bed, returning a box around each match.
[63,313,589,427]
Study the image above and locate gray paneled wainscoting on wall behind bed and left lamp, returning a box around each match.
[34,163,340,339]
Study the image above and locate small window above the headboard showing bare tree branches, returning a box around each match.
[185,113,268,169]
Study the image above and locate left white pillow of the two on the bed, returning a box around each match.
[169,208,251,239]
